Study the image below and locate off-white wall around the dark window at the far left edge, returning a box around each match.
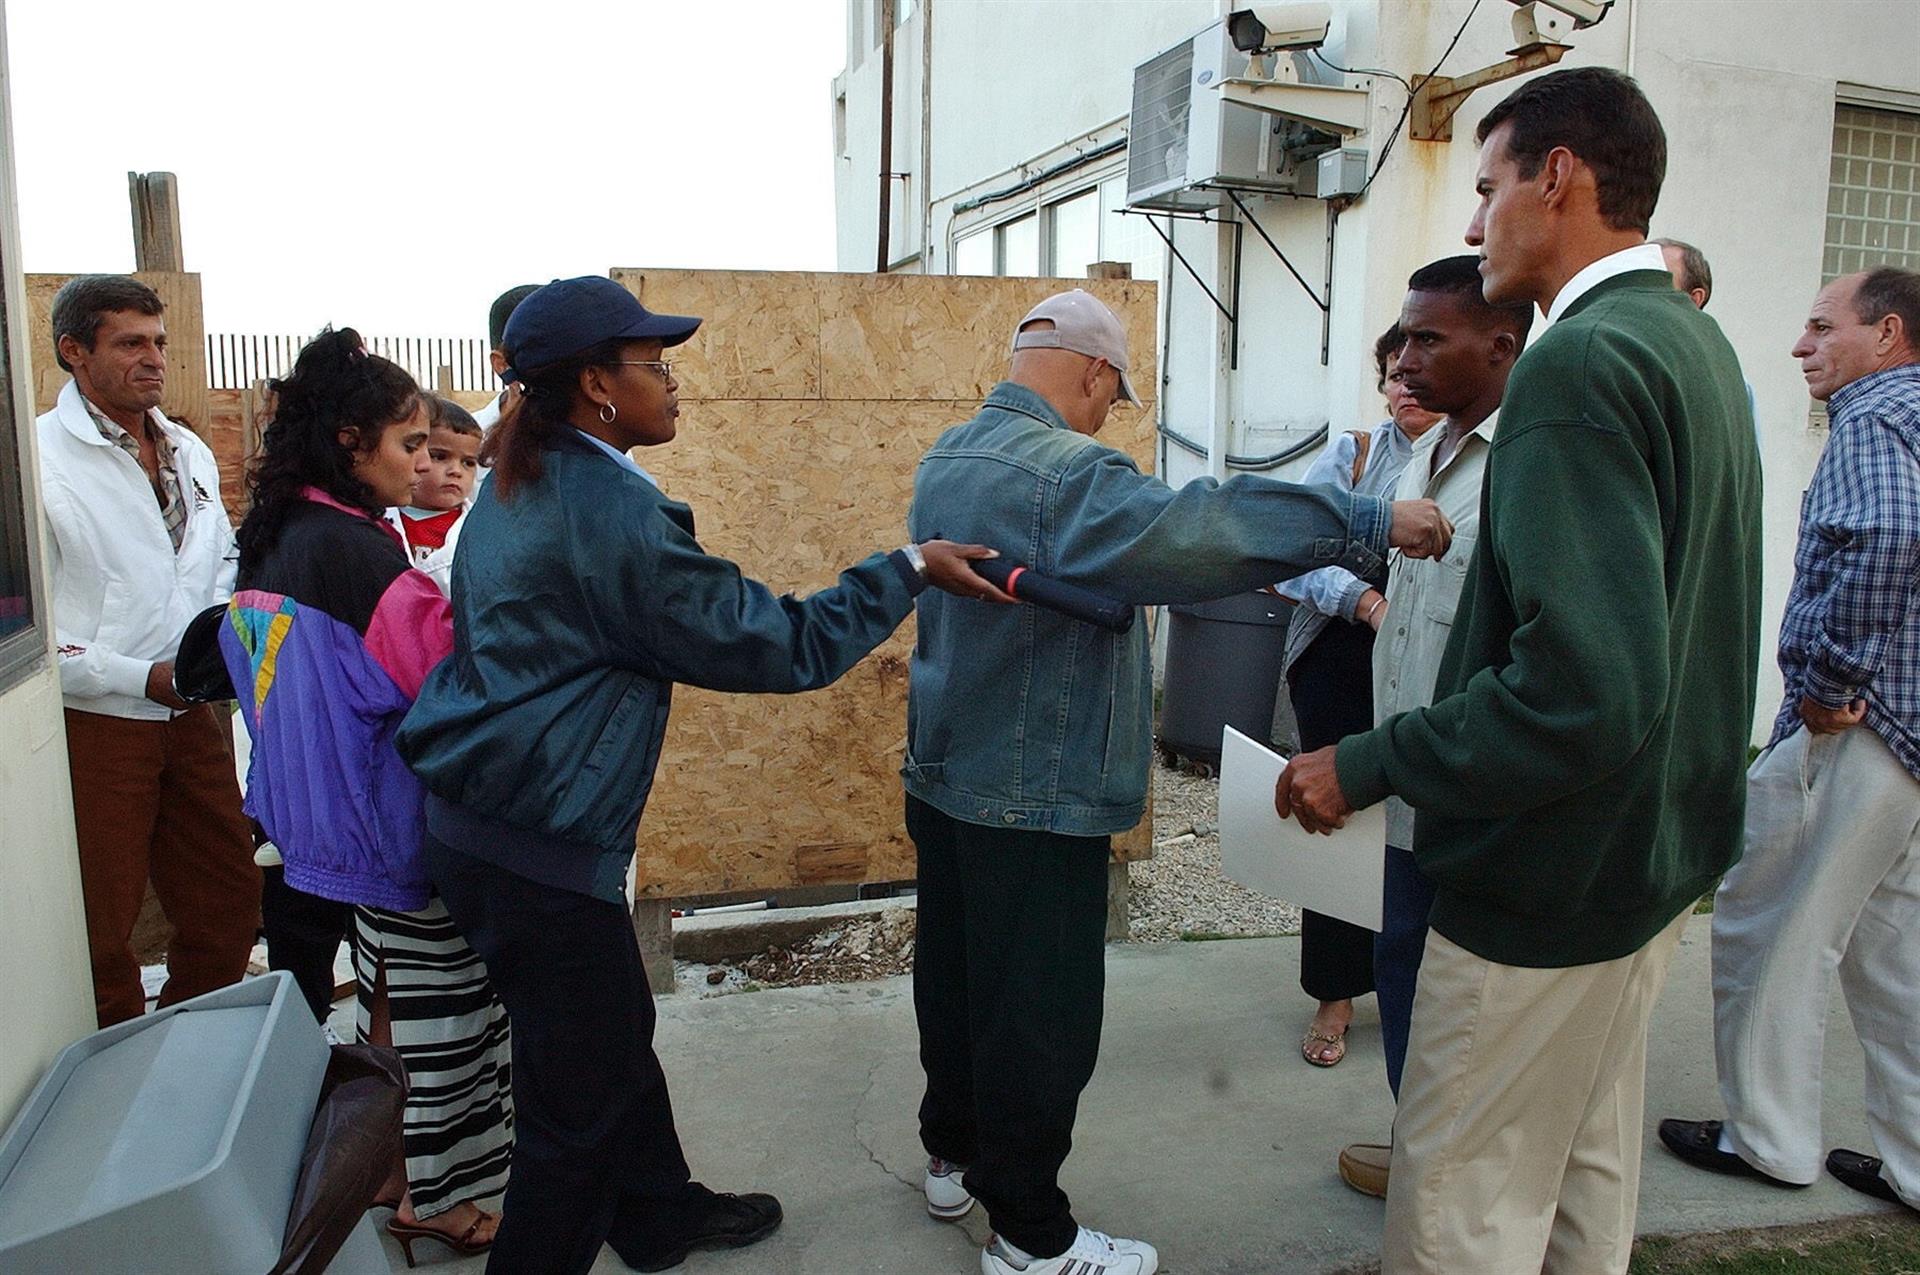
[0,8,94,1129]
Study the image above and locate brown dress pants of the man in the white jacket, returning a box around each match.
[67,705,259,1027]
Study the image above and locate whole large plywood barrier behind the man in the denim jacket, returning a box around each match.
[612,269,1158,899]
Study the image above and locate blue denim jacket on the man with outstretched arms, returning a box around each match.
[902,382,1392,837]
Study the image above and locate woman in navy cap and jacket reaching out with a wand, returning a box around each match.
[399,278,1010,1273]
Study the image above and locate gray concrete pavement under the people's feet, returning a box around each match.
[378,918,1893,1275]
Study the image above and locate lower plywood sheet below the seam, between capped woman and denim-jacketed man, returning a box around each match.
[637,399,940,897]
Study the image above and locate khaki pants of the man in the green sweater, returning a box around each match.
[1380,912,1688,1275]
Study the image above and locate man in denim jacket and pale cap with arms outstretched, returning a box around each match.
[902,290,1452,1275]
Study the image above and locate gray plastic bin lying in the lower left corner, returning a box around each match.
[0,974,337,1275]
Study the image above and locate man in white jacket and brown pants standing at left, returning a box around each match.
[36,275,259,1027]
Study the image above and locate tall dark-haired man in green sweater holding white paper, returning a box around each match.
[1275,67,1761,1275]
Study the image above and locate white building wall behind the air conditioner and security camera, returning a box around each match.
[839,0,1920,734]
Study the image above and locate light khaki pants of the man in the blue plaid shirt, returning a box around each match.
[1713,726,1920,1208]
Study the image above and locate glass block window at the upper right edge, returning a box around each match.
[1820,104,1920,282]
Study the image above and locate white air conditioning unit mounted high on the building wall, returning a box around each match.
[1127,19,1340,211]
